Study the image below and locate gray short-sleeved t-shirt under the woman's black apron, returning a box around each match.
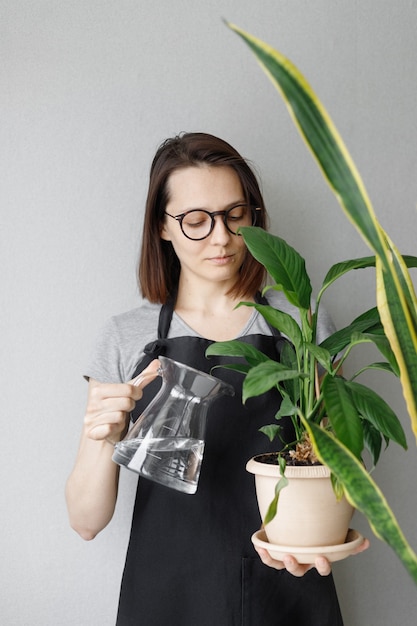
[85,289,335,383]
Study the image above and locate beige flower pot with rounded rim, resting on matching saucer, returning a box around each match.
[246,455,354,547]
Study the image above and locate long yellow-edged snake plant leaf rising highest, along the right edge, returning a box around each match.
[228,24,417,446]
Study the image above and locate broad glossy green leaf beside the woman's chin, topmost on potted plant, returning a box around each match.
[239,226,312,309]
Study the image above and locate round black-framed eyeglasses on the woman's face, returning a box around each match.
[164,204,260,241]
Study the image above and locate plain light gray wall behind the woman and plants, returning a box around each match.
[0,0,417,626]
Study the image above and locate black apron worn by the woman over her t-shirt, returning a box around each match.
[117,298,342,626]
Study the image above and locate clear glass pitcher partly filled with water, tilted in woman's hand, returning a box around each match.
[113,356,234,494]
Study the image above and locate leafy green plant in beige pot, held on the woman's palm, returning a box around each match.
[207,227,408,548]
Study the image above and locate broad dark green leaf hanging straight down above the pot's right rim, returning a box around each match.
[322,376,363,458]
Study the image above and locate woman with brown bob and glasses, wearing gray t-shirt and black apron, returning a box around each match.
[67,133,342,626]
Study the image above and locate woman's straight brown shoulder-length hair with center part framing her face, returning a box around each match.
[138,133,267,304]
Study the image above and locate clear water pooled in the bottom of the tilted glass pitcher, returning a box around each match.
[114,437,204,494]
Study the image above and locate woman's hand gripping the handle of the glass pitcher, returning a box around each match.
[84,360,160,444]
